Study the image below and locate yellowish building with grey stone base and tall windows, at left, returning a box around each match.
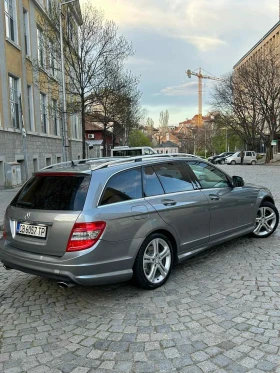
[0,0,82,187]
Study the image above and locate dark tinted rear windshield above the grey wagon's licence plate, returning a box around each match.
[11,175,91,211]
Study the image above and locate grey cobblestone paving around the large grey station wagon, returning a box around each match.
[0,166,280,373]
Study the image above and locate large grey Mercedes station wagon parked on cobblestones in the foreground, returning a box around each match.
[0,156,279,289]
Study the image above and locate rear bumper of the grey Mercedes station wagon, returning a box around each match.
[0,239,137,286]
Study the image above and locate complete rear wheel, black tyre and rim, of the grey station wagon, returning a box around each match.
[133,233,174,290]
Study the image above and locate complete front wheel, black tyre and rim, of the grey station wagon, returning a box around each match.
[253,201,279,238]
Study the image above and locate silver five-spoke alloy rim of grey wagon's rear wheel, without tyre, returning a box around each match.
[143,238,172,284]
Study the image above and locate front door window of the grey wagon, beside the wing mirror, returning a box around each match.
[187,161,229,189]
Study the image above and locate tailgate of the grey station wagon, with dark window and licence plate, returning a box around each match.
[5,172,91,256]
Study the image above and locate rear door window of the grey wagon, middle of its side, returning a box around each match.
[153,162,193,193]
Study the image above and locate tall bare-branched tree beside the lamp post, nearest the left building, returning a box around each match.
[34,0,133,158]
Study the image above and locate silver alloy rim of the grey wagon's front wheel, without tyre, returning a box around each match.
[253,206,277,237]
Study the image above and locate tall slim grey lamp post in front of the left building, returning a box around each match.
[59,0,76,162]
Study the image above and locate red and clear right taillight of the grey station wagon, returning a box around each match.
[66,221,106,251]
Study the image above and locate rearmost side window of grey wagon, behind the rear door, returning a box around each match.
[100,169,143,205]
